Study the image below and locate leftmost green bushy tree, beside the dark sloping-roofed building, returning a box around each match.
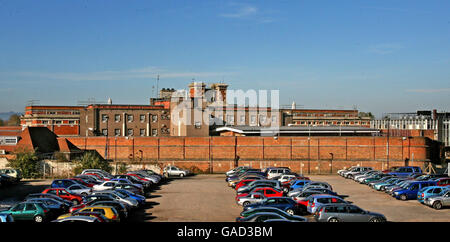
[8,150,41,178]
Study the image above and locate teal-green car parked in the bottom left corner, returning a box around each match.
[0,202,53,223]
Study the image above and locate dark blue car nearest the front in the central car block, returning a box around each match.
[244,197,304,215]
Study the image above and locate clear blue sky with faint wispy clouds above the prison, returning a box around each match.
[0,0,450,115]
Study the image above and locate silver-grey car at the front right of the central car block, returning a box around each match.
[314,204,387,222]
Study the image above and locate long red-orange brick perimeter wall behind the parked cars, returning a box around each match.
[67,136,431,173]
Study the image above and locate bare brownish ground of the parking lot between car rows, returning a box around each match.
[0,174,450,222]
